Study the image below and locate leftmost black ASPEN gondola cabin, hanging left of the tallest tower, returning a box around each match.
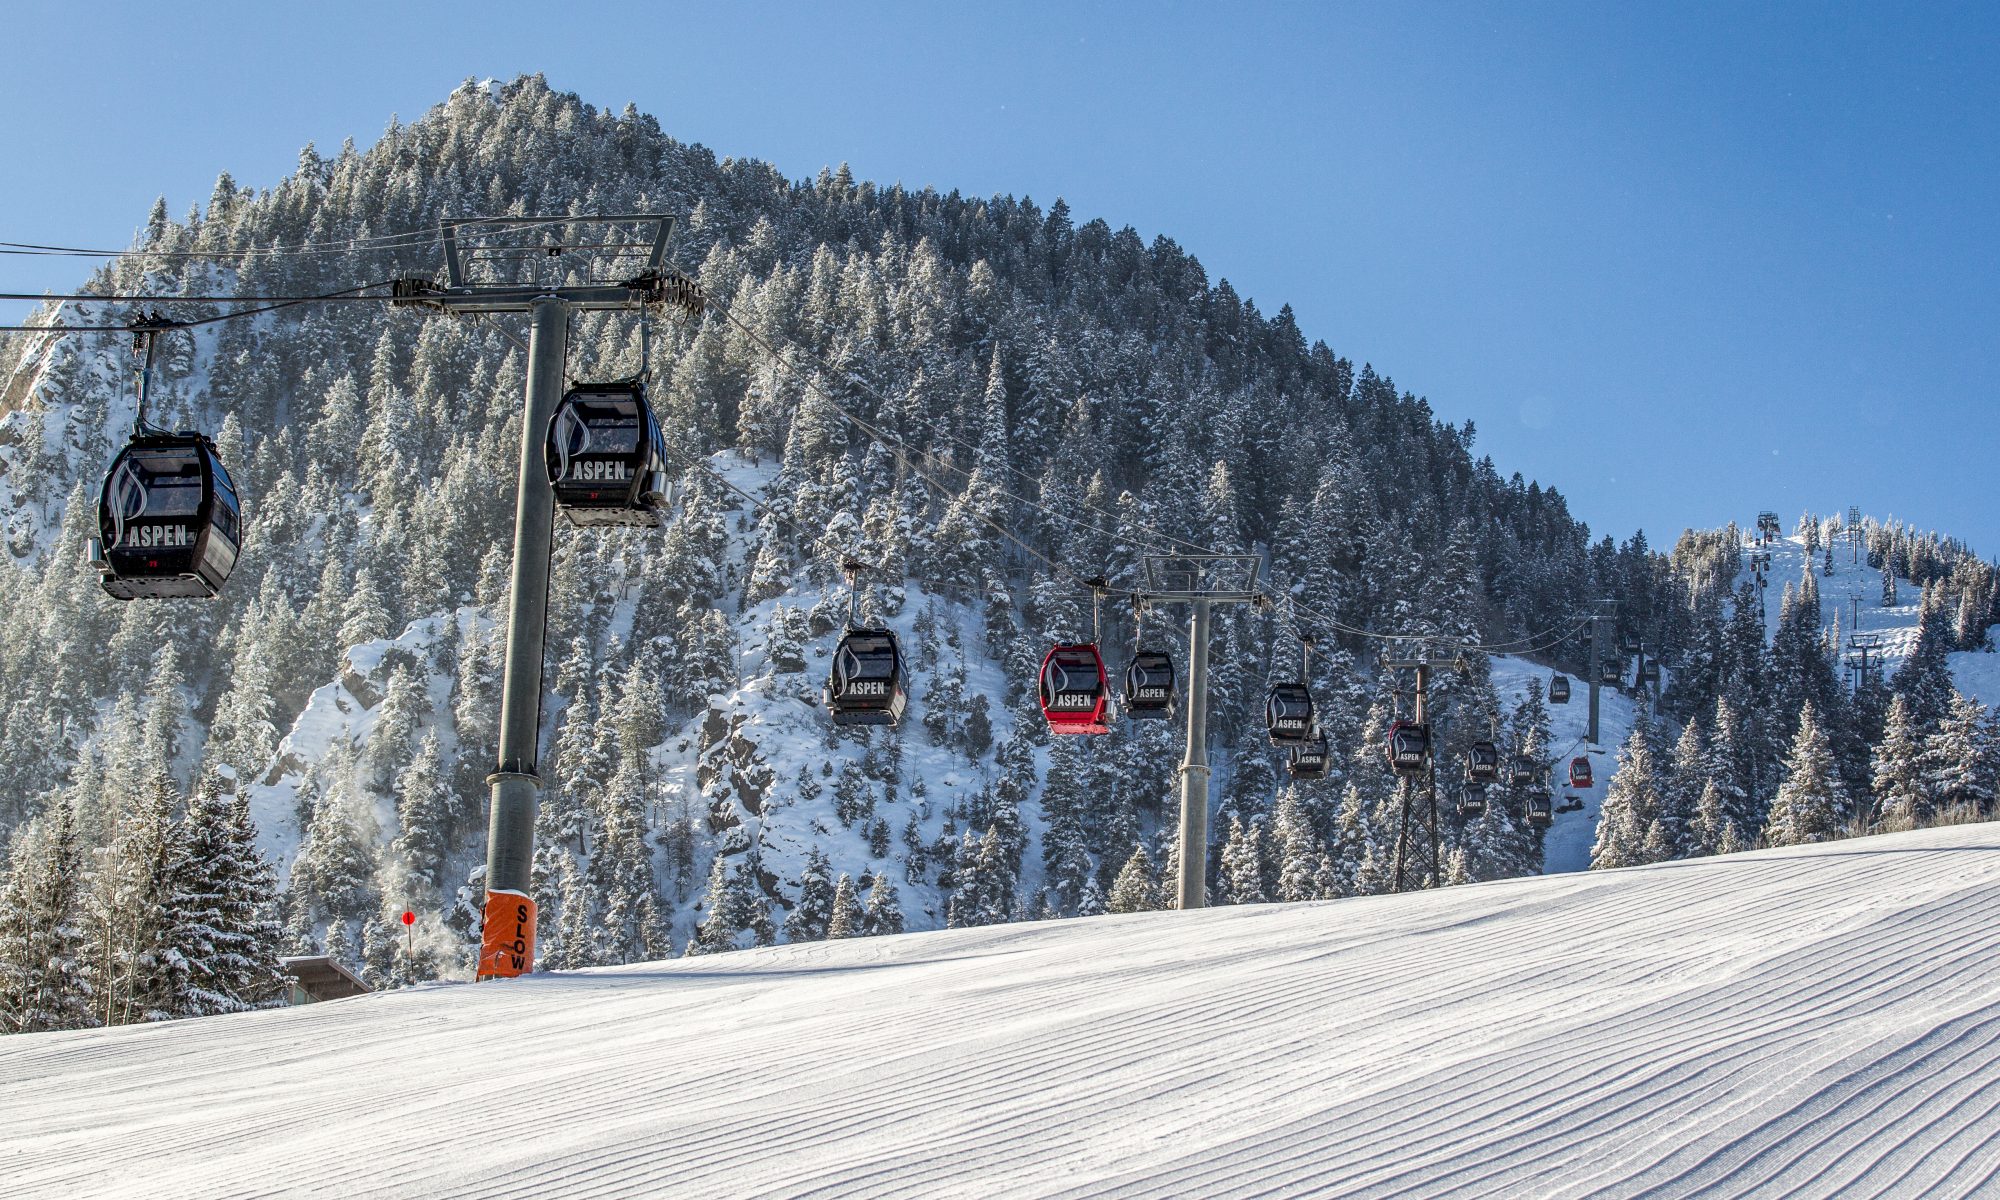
[88,430,242,600]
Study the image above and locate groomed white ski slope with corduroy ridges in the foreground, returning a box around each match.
[0,824,2000,1198]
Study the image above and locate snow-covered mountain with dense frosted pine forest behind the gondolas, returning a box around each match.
[0,76,1994,1000]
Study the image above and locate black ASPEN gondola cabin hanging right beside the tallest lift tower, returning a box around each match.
[544,382,674,526]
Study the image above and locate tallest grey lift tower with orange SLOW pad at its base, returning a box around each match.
[394,214,702,980]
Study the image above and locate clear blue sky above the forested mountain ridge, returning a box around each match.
[0,0,2000,554]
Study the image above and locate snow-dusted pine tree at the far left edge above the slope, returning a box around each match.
[0,804,96,1034]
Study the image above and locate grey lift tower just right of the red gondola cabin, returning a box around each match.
[1146,554,1264,908]
